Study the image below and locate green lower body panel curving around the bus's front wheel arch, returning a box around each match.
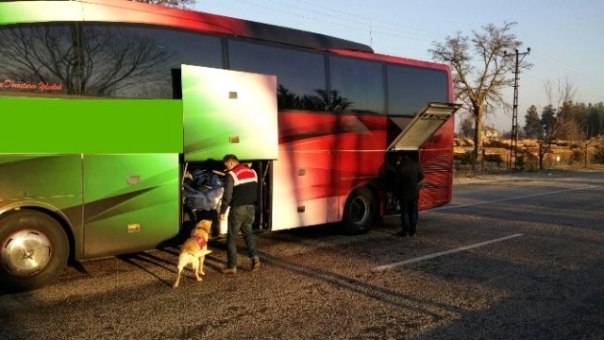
[0,154,82,258]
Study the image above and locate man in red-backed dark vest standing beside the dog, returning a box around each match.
[220,155,260,274]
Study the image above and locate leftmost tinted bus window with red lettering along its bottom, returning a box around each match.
[0,24,77,95]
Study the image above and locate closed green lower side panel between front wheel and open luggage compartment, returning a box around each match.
[84,154,180,258]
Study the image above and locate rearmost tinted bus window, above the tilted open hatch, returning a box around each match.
[386,65,449,116]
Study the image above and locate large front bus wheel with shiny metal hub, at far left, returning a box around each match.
[0,210,69,291]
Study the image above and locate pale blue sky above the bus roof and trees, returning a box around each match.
[192,0,604,132]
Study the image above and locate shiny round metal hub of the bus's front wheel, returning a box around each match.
[0,230,52,277]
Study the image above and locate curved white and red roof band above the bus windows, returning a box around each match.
[0,0,373,53]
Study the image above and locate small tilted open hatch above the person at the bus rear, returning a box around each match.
[387,103,461,151]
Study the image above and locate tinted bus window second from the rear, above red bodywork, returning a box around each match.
[329,56,385,114]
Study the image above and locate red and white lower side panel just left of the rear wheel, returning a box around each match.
[272,112,386,230]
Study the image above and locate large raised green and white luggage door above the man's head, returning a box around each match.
[181,65,278,162]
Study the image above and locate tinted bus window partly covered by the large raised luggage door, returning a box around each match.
[229,40,326,111]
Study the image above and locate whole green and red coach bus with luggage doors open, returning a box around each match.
[0,0,459,290]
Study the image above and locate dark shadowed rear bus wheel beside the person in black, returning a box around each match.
[342,188,378,235]
